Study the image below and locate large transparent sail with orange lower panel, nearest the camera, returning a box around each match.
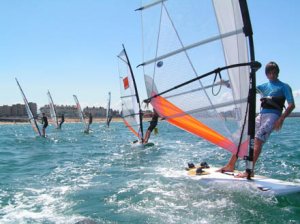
[139,0,260,157]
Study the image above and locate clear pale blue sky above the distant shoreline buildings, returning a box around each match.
[0,0,300,111]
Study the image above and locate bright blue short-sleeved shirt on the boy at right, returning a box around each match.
[256,79,294,116]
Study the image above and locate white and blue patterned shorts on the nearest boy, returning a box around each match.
[255,113,279,142]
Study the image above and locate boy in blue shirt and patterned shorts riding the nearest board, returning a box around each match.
[219,62,295,178]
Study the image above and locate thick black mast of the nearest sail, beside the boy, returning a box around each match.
[239,0,260,179]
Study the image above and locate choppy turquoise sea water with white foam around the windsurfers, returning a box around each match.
[0,118,300,224]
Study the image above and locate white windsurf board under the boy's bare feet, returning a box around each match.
[187,166,300,195]
